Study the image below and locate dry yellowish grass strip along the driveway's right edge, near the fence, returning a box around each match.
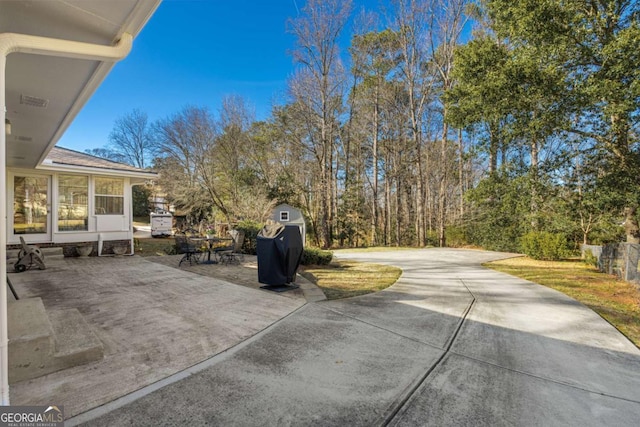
[485,257,640,347]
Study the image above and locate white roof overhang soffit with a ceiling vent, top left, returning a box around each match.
[0,0,161,168]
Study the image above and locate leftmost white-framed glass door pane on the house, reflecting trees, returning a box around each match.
[10,174,51,242]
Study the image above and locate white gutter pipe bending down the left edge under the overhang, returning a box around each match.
[0,33,133,406]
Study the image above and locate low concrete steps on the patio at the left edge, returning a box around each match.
[7,298,104,383]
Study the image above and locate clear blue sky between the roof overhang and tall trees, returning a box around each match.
[58,0,378,151]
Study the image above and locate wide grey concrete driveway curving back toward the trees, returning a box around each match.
[69,249,640,426]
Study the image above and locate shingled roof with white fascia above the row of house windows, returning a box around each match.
[42,147,157,178]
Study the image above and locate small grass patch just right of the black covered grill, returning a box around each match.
[302,261,402,300]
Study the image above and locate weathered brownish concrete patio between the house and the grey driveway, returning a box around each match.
[9,256,310,417]
